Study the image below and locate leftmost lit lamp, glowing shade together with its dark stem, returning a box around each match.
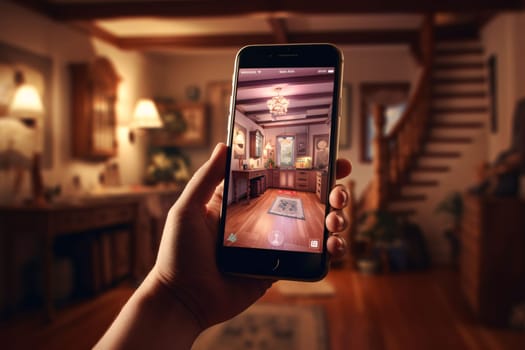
[9,84,46,206]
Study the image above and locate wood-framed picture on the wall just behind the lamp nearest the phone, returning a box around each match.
[150,102,210,147]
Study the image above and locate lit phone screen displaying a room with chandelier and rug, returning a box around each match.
[224,67,335,253]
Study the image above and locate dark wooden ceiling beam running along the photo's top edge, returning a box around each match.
[17,0,524,21]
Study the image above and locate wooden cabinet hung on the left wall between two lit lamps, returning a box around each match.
[69,57,120,160]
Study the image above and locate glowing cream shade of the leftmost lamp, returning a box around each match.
[9,84,44,119]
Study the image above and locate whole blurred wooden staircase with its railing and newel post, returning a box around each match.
[356,22,489,261]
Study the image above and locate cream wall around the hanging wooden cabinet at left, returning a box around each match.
[0,2,150,202]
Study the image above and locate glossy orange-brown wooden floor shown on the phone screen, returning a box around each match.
[225,189,325,252]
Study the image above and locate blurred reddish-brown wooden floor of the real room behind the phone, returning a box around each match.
[0,268,525,350]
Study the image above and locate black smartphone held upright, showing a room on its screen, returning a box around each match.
[217,44,343,281]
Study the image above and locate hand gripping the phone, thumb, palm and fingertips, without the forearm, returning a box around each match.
[154,144,351,328]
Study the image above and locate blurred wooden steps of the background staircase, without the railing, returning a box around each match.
[387,40,489,215]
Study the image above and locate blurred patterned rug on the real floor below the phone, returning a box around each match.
[192,303,328,350]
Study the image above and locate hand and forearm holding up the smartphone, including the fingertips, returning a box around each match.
[96,144,351,349]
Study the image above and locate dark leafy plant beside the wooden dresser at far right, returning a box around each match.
[436,191,463,267]
